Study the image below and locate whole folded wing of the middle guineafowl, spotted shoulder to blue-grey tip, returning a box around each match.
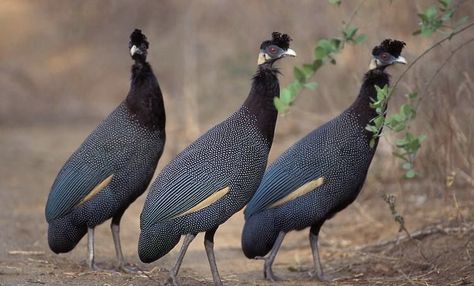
[141,108,261,228]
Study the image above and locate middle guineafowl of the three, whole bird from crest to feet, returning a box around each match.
[138,32,295,285]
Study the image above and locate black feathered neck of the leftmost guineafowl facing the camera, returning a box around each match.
[126,61,166,131]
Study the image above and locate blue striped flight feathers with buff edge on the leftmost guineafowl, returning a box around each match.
[46,164,113,222]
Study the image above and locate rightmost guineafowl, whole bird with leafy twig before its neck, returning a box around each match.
[242,39,406,281]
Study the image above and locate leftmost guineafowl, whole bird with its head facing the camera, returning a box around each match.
[45,29,166,271]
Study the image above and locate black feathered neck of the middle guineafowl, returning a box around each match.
[243,63,280,147]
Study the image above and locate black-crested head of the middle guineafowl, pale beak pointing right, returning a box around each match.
[257,32,296,65]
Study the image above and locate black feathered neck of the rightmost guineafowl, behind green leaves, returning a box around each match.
[347,68,390,140]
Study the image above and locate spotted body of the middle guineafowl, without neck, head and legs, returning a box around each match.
[139,104,270,262]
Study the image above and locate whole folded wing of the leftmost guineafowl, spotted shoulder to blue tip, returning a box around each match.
[46,103,142,221]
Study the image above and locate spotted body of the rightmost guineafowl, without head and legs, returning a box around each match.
[242,71,388,255]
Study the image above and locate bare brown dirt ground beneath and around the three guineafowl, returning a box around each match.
[0,125,474,286]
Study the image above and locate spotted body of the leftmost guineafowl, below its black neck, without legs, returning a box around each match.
[46,103,165,249]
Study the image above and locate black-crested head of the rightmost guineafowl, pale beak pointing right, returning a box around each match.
[369,39,407,70]
